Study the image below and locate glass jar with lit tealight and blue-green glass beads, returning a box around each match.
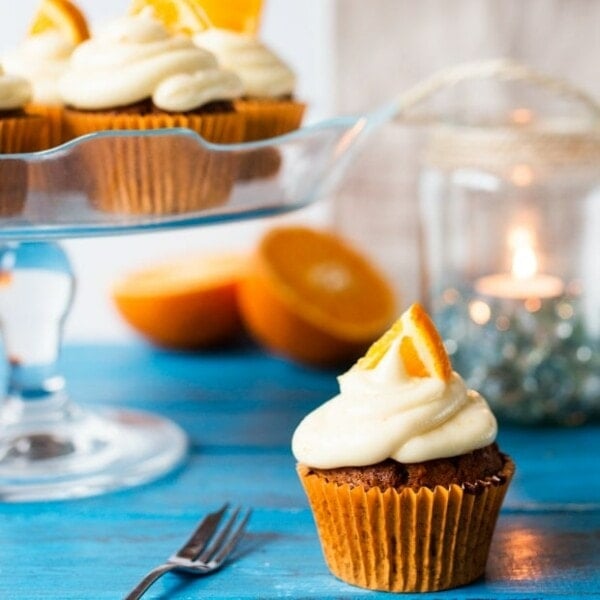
[420,119,600,425]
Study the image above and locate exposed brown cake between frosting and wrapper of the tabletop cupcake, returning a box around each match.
[304,444,506,494]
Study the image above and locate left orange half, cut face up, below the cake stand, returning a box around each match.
[112,255,246,350]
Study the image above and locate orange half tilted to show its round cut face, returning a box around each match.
[239,226,395,366]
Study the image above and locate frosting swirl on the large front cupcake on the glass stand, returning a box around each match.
[59,11,242,111]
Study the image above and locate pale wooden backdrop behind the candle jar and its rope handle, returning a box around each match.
[334,0,600,304]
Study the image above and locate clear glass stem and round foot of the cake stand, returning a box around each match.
[0,242,187,501]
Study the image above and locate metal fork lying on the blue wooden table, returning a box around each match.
[125,504,251,600]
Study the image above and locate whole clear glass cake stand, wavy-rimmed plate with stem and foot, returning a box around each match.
[0,107,393,502]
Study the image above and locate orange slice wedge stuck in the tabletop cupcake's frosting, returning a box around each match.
[358,303,452,381]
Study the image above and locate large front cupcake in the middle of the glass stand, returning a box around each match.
[60,11,244,214]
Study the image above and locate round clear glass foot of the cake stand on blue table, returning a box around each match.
[0,406,187,502]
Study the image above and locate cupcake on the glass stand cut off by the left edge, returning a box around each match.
[0,67,46,217]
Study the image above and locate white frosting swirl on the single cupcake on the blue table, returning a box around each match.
[292,332,497,469]
